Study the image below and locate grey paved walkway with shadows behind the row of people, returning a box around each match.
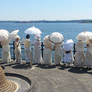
[2,65,92,92]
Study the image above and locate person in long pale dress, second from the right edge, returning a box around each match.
[74,40,85,67]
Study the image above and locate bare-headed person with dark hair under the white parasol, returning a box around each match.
[24,34,32,66]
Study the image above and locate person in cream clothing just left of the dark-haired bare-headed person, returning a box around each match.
[14,36,22,63]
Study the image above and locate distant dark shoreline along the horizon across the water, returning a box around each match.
[0,20,92,23]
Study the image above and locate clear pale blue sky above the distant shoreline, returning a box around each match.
[0,0,92,21]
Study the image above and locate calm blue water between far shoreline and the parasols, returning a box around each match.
[0,23,92,41]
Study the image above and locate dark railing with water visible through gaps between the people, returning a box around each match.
[0,42,76,60]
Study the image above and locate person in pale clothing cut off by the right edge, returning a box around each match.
[85,39,92,68]
